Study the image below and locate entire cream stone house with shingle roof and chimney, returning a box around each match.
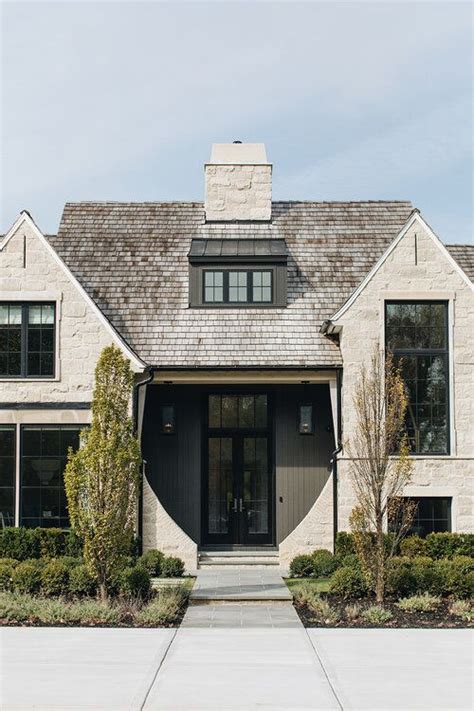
[0,143,474,569]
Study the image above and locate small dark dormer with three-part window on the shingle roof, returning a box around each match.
[189,239,287,308]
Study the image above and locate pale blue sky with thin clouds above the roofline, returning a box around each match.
[0,1,473,242]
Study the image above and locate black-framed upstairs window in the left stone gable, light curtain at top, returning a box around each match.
[0,303,56,378]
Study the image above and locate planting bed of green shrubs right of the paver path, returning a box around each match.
[286,532,474,628]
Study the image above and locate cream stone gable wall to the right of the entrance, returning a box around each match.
[337,220,474,532]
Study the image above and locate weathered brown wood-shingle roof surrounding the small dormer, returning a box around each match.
[49,201,422,367]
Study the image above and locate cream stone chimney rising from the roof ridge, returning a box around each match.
[204,141,272,222]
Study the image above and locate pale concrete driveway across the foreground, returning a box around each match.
[0,628,472,711]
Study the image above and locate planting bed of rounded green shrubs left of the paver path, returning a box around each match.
[0,528,194,627]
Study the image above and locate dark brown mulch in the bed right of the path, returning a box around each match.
[293,595,474,629]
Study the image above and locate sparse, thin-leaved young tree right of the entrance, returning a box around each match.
[347,349,415,602]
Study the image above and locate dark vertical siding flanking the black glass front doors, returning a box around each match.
[142,385,334,543]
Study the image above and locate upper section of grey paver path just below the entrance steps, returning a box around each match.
[191,566,292,601]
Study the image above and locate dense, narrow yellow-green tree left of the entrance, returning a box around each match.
[64,345,141,599]
